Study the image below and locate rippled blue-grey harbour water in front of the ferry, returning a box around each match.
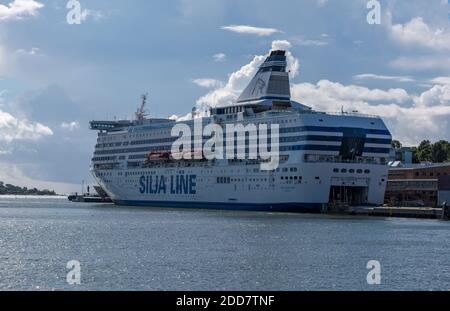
[0,197,450,290]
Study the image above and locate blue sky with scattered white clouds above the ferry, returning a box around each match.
[0,0,450,193]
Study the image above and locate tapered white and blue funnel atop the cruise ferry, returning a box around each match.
[237,50,291,103]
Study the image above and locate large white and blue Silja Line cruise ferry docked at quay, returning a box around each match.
[90,50,392,212]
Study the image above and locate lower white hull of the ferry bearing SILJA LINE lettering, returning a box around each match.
[93,163,388,212]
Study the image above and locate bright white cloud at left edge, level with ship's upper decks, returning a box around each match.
[0,110,53,143]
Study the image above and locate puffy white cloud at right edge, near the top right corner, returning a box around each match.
[388,15,450,51]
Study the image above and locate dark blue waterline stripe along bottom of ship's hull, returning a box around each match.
[114,200,322,213]
